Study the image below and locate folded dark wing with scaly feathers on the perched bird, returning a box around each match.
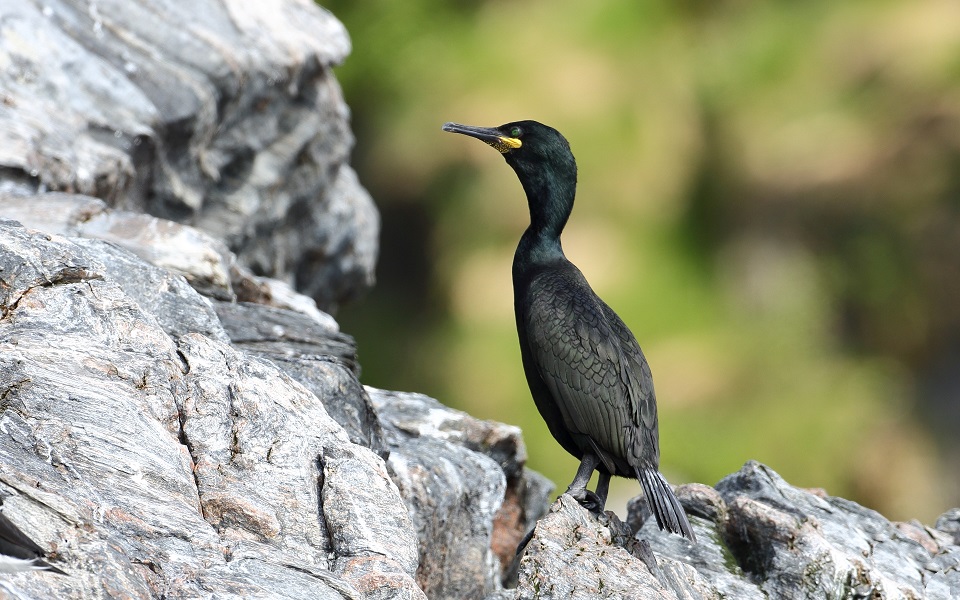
[524,272,657,475]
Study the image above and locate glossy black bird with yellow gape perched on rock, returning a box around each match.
[443,121,696,541]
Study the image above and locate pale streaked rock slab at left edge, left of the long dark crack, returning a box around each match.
[0,220,230,598]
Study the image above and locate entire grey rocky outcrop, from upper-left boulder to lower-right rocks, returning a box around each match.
[0,0,960,600]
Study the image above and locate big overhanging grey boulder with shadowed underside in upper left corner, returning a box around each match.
[0,0,379,310]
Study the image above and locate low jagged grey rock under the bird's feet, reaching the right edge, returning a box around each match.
[515,462,960,600]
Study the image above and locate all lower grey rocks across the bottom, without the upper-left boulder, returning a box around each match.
[0,221,960,600]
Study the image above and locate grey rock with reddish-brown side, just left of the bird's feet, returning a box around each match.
[368,388,552,598]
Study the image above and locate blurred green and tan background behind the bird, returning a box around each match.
[321,0,960,523]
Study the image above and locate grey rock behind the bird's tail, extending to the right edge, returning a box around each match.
[628,462,960,599]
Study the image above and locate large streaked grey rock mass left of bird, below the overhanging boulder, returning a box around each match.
[0,210,536,598]
